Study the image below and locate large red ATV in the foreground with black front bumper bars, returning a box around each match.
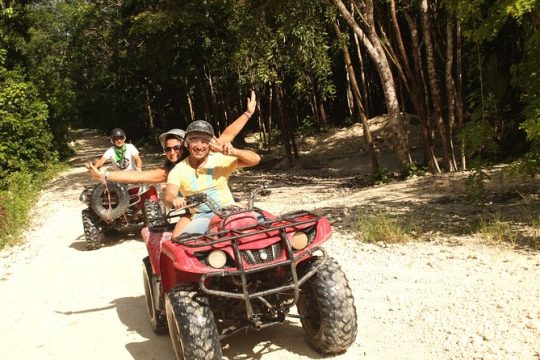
[142,187,357,360]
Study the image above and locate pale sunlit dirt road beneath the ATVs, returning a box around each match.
[0,131,540,360]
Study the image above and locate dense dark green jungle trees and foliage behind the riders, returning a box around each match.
[0,0,540,180]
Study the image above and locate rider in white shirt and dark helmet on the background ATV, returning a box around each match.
[95,128,142,171]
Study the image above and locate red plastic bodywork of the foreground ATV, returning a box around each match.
[141,211,332,292]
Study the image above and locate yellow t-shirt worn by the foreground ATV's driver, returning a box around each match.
[167,152,238,213]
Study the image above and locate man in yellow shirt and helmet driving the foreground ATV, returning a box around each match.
[164,120,261,237]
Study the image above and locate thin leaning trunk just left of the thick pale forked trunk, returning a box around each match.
[334,22,379,174]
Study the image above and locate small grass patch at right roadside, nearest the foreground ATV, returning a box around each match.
[355,213,416,244]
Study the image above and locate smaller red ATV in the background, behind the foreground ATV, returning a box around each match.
[79,182,158,250]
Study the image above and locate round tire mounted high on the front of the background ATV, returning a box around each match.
[90,182,129,221]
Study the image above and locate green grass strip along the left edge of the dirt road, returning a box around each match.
[0,164,67,249]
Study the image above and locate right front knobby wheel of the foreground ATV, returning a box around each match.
[297,258,357,354]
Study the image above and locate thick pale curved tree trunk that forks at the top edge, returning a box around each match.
[334,0,410,171]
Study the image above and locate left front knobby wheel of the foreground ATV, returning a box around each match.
[165,285,221,360]
